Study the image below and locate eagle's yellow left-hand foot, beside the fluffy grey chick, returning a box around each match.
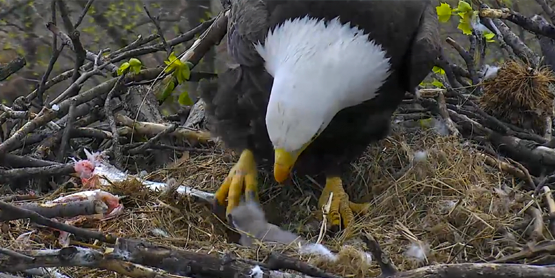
[215,150,258,220]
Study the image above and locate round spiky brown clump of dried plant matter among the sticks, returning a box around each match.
[480,60,555,135]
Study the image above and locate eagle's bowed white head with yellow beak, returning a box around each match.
[255,16,390,182]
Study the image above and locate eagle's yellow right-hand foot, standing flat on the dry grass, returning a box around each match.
[318,177,370,232]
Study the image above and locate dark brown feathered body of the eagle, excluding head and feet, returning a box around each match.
[202,0,440,174]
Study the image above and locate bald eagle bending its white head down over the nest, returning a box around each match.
[201,0,440,228]
